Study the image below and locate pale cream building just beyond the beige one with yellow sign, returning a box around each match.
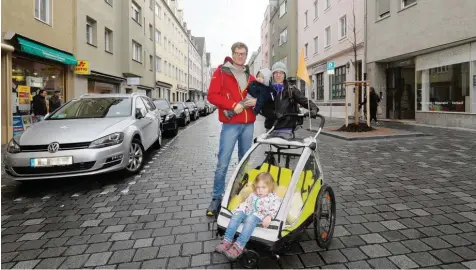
[155,0,190,102]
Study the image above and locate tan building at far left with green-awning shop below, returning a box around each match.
[1,0,77,144]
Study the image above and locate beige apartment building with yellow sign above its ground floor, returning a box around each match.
[74,0,156,97]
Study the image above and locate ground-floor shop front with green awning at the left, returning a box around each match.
[2,34,77,143]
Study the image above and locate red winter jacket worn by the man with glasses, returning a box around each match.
[208,57,256,124]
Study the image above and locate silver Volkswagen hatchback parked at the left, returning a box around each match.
[5,94,162,180]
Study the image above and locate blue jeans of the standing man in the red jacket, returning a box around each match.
[213,123,254,199]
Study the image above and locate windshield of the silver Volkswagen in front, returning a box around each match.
[48,97,132,120]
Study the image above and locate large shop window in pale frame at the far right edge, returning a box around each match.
[415,43,476,128]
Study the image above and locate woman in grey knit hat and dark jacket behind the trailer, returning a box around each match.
[262,62,319,138]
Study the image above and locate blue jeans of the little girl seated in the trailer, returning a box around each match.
[224,211,261,248]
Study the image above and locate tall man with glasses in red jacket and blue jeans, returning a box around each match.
[207,42,256,216]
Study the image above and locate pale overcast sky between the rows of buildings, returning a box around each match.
[179,0,269,67]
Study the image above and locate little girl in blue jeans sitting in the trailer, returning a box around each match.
[215,172,281,260]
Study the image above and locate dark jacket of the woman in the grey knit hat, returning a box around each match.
[261,84,319,130]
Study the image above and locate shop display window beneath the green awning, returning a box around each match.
[10,56,65,136]
